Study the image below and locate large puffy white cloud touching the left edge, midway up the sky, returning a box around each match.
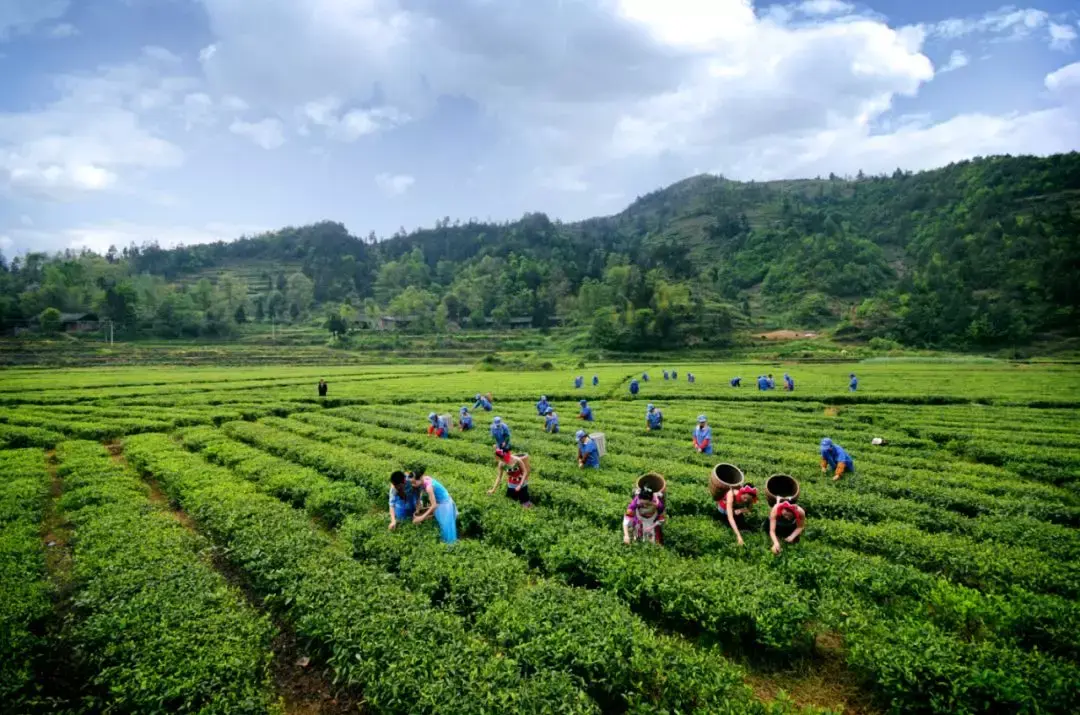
[0,56,187,200]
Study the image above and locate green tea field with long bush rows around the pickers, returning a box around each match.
[0,360,1080,713]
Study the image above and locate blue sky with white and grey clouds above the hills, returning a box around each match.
[0,0,1080,257]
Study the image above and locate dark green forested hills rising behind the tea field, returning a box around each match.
[0,152,1080,350]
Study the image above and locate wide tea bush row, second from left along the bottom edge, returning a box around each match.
[57,442,274,713]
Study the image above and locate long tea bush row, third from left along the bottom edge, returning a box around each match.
[125,434,597,714]
